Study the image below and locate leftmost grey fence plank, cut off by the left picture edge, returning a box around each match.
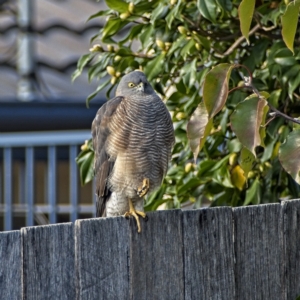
[0,231,22,300]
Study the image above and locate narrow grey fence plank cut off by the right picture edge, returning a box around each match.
[282,200,300,300]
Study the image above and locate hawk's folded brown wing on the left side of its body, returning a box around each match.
[92,97,123,217]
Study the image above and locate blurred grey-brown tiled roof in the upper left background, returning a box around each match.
[0,0,106,102]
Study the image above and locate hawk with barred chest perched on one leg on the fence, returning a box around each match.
[92,71,174,232]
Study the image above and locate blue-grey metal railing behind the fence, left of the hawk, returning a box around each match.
[0,130,95,230]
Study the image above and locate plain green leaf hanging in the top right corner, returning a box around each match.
[281,0,300,54]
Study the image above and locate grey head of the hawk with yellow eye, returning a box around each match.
[116,71,154,97]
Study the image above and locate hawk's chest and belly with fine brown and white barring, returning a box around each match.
[107,98,173,197]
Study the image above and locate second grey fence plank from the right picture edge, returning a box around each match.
[233,204,283,300]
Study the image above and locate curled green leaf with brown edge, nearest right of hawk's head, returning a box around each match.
[203,64,233,118]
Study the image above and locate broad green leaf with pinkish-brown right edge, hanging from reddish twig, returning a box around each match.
[230,96,267,155]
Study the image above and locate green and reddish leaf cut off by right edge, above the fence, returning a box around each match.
[278,129,300,184]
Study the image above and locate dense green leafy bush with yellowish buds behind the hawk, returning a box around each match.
[73,0,300,210]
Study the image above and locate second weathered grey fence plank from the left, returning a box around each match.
[21,223,75,300]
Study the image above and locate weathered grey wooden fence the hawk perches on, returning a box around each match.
[0,200,300,300]
